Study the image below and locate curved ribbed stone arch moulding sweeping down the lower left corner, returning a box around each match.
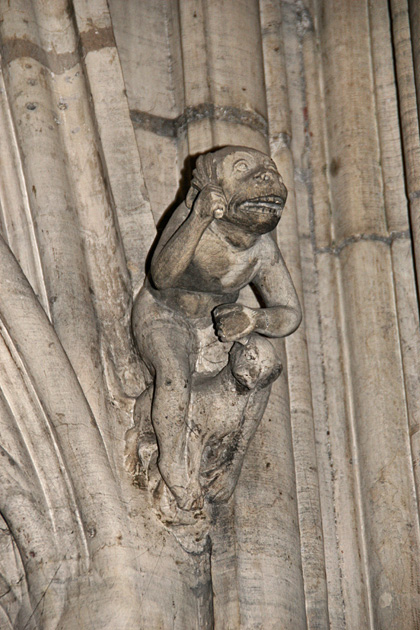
[0,237,141,630]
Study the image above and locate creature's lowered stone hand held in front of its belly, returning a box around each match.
[213,304,257,341]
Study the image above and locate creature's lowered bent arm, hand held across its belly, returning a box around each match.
[213,238,302,341]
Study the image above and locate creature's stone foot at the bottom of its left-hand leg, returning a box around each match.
[158,457,204,510]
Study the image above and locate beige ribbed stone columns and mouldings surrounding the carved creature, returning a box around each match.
[0,0,420,630]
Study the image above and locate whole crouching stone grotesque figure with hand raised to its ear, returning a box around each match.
[133,147,301,511]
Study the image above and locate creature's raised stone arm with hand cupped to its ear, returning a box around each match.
[151,184,226,289]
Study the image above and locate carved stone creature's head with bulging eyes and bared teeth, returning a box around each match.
[186,146,287,234]
